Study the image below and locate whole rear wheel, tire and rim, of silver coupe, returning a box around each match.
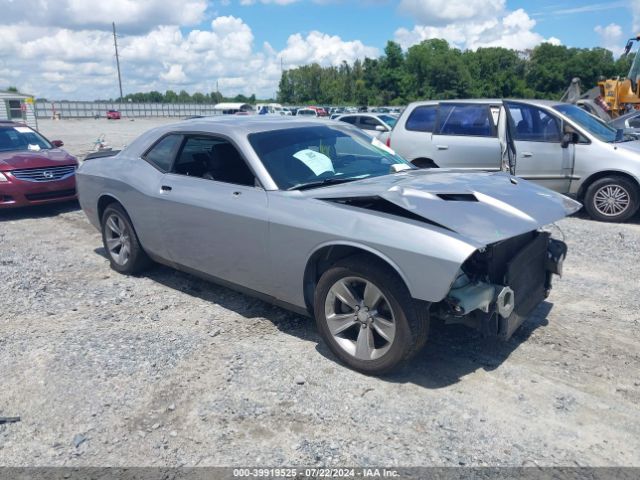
[102,203,151,274]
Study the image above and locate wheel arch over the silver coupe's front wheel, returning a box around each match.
[303,242,410,315]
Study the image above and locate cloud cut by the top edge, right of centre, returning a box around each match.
[398,0,505,25]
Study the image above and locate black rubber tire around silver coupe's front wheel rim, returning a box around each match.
[314,255,429,375]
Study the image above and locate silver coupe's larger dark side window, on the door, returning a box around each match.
[173,135,255,187]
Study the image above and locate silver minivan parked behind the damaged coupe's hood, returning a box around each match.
[386,99,640,222]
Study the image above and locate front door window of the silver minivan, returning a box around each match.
[507,103,562,142]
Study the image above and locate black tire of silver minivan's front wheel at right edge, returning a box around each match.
[584,175,640,222]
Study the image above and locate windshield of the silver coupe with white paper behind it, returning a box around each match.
[249,125,412,190]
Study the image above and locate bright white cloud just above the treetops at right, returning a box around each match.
[395,8,560,50]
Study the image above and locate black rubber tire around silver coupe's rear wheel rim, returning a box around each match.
[101,203,151,275]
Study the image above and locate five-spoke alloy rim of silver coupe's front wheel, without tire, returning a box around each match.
[325,277,396,360]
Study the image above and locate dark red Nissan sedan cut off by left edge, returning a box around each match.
[0,122,78,209]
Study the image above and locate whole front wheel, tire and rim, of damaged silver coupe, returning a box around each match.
[314,256,429,375]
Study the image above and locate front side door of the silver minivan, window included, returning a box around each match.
[505,102,575,193]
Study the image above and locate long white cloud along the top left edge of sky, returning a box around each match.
[0,0,207,32]
